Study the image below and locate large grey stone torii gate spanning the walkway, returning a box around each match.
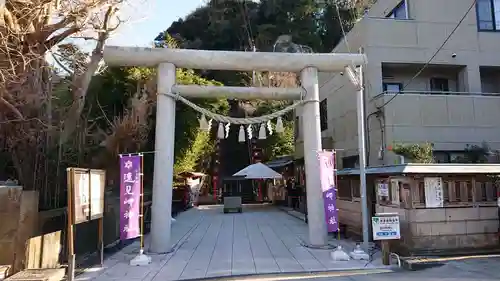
[104,46,366,253]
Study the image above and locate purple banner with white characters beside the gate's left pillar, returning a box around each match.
[120,155,141,240]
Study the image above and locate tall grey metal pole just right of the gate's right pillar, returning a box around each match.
[356,66,370,248]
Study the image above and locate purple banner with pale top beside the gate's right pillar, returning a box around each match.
[318,151,339,232]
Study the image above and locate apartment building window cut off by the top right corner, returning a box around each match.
[476,0,500,31]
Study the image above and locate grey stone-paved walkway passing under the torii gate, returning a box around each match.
[77,203,390,281]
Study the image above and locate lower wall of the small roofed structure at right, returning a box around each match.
[337,177,499,254]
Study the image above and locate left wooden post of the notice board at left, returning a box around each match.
[66,168,75,281]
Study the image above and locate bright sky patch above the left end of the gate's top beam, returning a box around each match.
[107,0,205,47]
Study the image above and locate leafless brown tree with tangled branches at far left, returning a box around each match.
[0,0,131,194]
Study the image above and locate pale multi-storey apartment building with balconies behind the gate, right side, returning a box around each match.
[295,0,500,168]
